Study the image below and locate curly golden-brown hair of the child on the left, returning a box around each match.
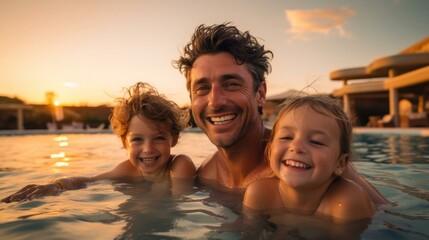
[110,82,189,148]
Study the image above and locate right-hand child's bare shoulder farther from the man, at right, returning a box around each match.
[319,178,375,222]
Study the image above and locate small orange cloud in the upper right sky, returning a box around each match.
[285,7,356,40]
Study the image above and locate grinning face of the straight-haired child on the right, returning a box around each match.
[268,105,345,188]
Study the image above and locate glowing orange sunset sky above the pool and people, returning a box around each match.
[0,0,429,106]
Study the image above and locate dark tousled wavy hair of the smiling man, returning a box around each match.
[173,23,273,92]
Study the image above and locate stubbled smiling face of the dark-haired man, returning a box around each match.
[190,53,265,147]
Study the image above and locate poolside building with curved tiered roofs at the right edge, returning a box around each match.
[330,37,429,127]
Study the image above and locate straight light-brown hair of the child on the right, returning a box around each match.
[266,94,353,159]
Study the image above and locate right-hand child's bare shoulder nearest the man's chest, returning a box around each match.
[243,178,282,210]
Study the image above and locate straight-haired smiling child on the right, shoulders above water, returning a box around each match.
[243,94,375,223]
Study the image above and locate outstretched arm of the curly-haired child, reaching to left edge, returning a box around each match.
[1,160,131,203]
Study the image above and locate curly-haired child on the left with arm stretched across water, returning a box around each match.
[1,82,196,202]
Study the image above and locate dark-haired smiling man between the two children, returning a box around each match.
[175,23,386,203]
